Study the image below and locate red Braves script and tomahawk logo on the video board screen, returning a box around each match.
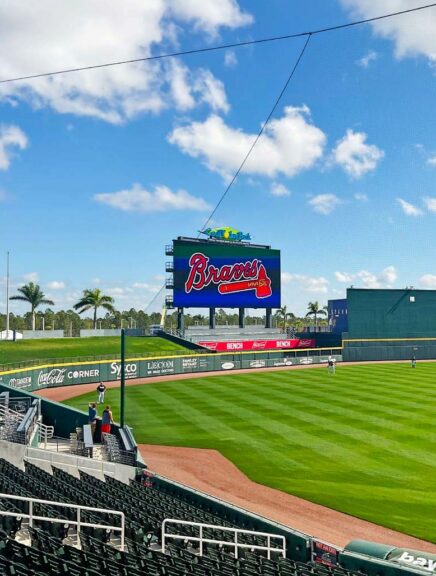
[185,252,272,298]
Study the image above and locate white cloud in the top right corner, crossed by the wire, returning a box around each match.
[341,0,436,63]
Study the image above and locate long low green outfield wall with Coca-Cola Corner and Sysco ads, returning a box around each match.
[0,348,342,392]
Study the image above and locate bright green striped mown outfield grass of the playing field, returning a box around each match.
[67,363,436,542]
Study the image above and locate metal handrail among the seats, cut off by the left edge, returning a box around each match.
[0,493,125,551]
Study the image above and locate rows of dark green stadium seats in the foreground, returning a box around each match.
[0,459,372,576]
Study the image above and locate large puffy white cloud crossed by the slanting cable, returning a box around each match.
[168,106,326,178]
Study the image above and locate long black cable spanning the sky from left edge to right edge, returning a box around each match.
[0,2,436,84]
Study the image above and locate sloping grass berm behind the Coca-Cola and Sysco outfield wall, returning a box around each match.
[0,336,187,364]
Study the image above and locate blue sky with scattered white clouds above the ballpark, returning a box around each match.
[0,0,436,313]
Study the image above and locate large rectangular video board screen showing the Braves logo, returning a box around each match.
[173,240,280,308]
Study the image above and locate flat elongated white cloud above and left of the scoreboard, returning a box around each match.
[94,184,211,212]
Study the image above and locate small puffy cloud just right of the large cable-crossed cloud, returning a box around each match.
[333,129,384,178]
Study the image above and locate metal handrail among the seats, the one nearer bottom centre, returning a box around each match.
[162,518,286,560]
